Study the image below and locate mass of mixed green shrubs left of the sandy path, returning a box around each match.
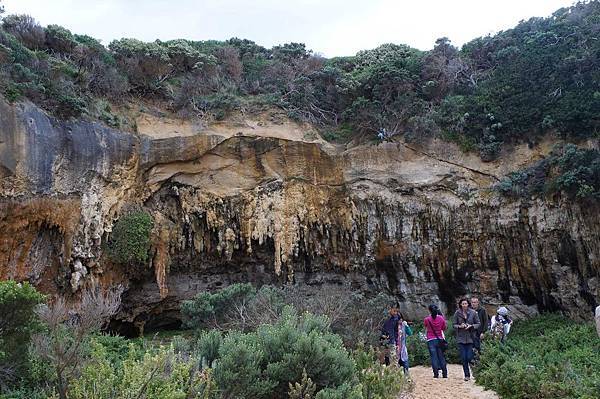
[0,282,410,399]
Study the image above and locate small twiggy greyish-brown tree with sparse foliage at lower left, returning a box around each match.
[33,290,121,399]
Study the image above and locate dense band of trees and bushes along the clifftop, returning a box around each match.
[0,1,600,155]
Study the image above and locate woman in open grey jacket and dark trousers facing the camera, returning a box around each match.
[453,298,481,381]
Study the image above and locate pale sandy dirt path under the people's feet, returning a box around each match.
[410,364,499,399]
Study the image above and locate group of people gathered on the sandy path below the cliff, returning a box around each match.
[382,297,512,381]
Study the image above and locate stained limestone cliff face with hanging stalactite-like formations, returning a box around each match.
[0,98,600,329]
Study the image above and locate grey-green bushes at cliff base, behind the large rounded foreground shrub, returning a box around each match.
[181,284,394,346]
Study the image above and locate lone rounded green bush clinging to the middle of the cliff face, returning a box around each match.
[107,211,154,264]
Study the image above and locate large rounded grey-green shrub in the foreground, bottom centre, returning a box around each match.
[214,308,355,398]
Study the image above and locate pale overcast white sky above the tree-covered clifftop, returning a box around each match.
[2,0,573,57]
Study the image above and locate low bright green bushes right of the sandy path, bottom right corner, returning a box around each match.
[476,315,600,399]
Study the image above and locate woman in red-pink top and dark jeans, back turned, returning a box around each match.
[423,304,448,378]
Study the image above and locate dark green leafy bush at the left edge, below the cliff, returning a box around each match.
[0,280,44,390]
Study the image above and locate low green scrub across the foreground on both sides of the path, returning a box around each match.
[0,281,600,399]
